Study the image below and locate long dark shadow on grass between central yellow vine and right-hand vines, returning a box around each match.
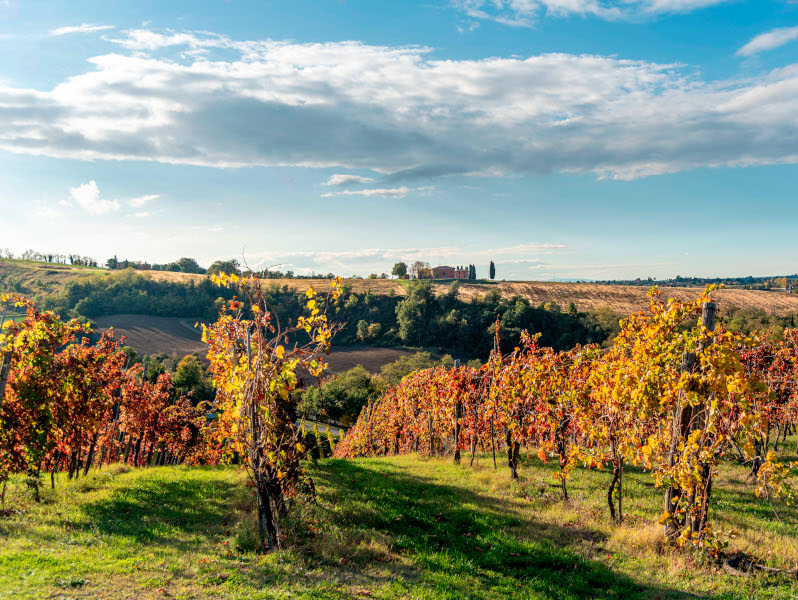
[315,460,690,598]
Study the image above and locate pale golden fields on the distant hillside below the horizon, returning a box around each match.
[0,259,798,315]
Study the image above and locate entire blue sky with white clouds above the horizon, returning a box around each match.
[0,0,798,280]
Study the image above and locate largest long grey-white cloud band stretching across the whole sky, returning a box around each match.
[0,30,798,179]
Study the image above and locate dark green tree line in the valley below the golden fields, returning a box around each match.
[26,269,618,359]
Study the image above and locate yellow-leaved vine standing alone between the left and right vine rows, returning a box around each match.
[202,273,341,551]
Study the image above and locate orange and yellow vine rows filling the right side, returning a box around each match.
[336,289,798,572]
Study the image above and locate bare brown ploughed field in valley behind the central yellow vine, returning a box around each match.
[94,314,413,373]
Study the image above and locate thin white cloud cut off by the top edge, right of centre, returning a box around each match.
[451,0,730,26]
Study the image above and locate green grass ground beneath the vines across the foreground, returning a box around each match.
[0,456,798,599]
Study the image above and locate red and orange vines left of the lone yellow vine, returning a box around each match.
[0,296,215,497]
